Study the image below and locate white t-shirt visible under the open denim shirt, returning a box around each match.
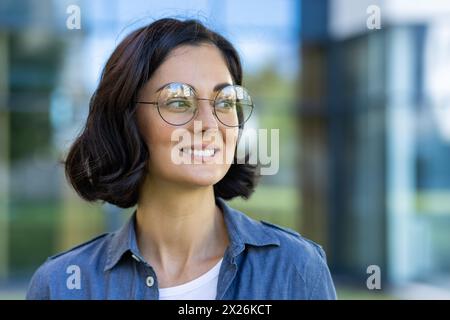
[159,258,223,300]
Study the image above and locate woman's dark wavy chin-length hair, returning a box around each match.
[64,18,259,208]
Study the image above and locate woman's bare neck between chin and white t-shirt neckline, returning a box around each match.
[136,175,228,273]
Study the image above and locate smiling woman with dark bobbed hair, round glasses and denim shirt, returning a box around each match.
[27,19,336,299]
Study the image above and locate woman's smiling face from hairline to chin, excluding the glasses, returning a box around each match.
[137,44,238,186]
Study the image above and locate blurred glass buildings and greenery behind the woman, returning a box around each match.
[0,0,450,299]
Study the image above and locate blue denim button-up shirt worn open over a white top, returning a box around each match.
[26,198,336,300]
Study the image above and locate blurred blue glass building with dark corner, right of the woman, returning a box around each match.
[299,0,450,289]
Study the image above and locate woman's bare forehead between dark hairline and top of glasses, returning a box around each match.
[149,44,233,91]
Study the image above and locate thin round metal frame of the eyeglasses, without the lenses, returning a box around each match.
[136,82,255,128]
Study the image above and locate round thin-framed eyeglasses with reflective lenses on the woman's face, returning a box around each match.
[137,82,254,127]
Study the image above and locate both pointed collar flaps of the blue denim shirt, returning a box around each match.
[104,197,280,271]
